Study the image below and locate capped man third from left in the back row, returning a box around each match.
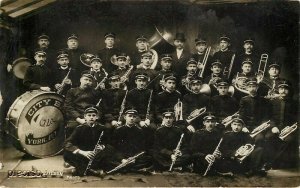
[98,32,119,73]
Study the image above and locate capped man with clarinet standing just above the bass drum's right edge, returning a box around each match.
[54,51,78,95]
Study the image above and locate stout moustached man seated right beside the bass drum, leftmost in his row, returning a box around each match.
[64,71,101,137]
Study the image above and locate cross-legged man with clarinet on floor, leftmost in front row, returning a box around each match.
[64,107,113,176]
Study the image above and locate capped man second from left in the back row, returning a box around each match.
[66,34,86,77]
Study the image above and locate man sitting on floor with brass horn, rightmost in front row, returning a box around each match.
[220,116,266,176]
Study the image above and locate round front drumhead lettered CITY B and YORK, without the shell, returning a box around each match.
[17,92,65,158]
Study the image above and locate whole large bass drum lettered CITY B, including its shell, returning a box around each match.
[6,90,65,158]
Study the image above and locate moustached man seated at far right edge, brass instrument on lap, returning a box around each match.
[264,80,299,170]
